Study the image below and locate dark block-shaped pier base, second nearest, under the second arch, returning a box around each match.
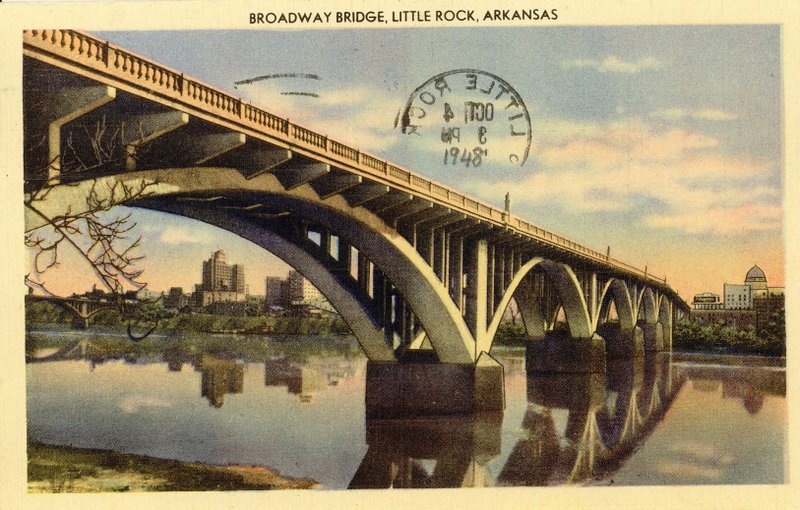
[525,331,606,373]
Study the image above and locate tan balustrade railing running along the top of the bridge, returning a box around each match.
[23,30,666,285]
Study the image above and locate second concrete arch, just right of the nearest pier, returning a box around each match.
[486,257,593,352]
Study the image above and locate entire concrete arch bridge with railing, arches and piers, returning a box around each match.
[23,30,689,412]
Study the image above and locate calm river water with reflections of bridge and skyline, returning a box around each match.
[27,337,787,489]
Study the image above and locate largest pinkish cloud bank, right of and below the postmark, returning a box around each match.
[464,119,783,235]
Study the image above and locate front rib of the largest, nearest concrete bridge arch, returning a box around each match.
[26,167,478,364]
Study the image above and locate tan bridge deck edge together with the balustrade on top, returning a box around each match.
[23,30,682,294]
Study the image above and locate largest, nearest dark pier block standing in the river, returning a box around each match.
[365,353,505,418]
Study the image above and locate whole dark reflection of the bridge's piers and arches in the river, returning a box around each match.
[350,354,686,488]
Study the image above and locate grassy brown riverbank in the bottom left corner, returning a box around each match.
[28,444,319,493]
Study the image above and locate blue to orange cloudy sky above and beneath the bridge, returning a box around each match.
[29,25,784,301]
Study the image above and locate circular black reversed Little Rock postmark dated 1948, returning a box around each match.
[394,69,531,168]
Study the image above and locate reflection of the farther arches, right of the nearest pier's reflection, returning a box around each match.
[498,356,685,485]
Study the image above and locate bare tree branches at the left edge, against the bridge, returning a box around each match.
[25,116,158,339]
